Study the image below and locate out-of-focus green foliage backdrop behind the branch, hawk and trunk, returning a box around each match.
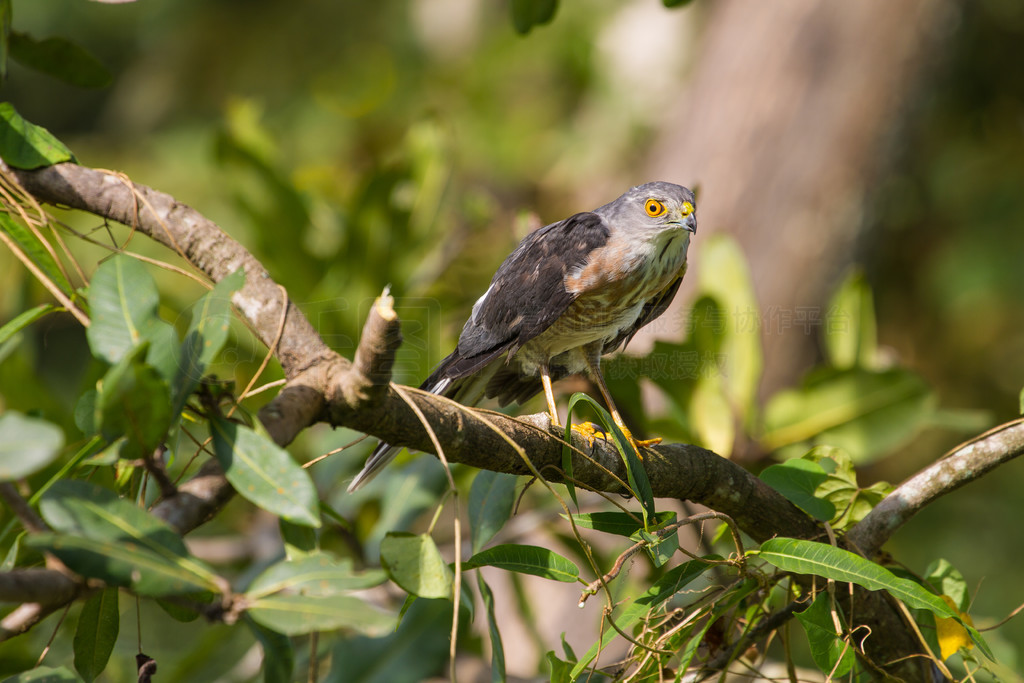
[0,0,1024,680]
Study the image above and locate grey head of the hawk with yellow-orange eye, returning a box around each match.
[594,181,697,232]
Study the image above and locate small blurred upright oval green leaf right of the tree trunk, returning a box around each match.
[824,270,879,370]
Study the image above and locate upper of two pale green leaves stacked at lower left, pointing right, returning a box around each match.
[246,552,387,599]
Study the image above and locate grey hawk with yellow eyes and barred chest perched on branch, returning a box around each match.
[348,182,697,492]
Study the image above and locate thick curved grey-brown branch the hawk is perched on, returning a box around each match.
[2,164,974,679]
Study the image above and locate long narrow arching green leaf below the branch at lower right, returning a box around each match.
[756,538,992,658]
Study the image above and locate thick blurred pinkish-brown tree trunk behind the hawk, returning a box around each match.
[646,0,956,403]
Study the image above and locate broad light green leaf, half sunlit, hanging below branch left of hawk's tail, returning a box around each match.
[381,531,453,600]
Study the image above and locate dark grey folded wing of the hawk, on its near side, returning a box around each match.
[425,212,609,384]
